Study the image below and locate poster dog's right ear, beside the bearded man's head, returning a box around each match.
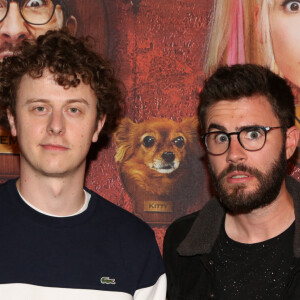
[181,117,201,155]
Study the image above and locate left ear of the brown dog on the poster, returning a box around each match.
[113,118,135,162]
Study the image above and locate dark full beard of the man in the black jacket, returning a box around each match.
[208,145,287,214]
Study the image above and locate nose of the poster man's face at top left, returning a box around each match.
[0,2,30,45]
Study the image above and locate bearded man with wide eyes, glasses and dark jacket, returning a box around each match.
[164,64,300,300]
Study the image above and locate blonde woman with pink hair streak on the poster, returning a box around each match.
[205,0,300,169]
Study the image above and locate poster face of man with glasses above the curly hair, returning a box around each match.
[0,0,77,60]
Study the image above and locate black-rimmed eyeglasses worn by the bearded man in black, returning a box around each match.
[201,126,282,155]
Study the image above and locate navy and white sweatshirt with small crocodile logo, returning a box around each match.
[0,180,166,300]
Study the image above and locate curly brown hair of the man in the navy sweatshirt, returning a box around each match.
[0,30,124,136]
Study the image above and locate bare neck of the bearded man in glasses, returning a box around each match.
[225,181,295,244]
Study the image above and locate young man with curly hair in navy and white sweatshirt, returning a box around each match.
[0,31,166,300]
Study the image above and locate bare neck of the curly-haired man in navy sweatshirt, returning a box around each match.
[17,164,84,216]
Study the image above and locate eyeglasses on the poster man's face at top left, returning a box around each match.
[0,0,59,25]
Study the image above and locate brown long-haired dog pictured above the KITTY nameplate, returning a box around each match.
[114,117,206,214]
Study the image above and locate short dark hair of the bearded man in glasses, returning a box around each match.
[198,64,295,133]
